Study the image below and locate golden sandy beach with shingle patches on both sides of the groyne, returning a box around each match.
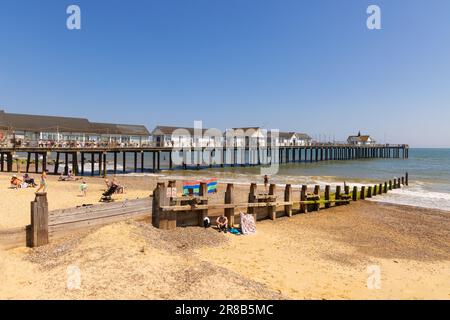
[0,171,450,299]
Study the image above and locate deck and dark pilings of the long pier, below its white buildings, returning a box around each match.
[0,144,409,176]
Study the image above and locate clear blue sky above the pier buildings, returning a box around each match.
[0,0,450,147]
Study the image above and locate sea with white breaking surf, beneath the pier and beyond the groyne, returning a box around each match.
[19,148,450,211]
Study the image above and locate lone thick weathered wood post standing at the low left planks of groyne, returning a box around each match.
[31,192,48,247]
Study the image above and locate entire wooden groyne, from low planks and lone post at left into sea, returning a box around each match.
[0,173,409,249]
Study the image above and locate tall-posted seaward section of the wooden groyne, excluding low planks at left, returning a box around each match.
[152,173,409,230]
